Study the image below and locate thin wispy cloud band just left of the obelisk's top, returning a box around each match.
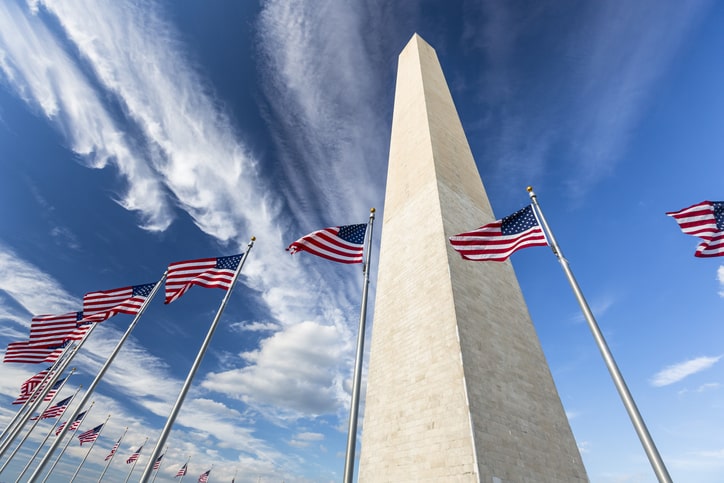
[258,0,389,228]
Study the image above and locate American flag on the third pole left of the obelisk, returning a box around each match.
[83,283,156,322]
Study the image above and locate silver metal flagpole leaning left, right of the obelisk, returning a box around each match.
[528,186,672,483]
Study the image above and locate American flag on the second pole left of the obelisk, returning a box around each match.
[165,255,241,304]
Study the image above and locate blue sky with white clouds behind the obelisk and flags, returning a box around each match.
[0,0,724,483]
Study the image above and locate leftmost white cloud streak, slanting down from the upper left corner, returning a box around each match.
[0,2,171,230]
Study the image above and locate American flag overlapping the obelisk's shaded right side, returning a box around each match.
[450,205,548,262]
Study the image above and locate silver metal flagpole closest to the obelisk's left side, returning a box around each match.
[344,208,375,483]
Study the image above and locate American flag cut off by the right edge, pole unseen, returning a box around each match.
[666,201,724,258]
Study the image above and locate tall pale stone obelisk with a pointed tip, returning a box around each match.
[359,34,588,483]
